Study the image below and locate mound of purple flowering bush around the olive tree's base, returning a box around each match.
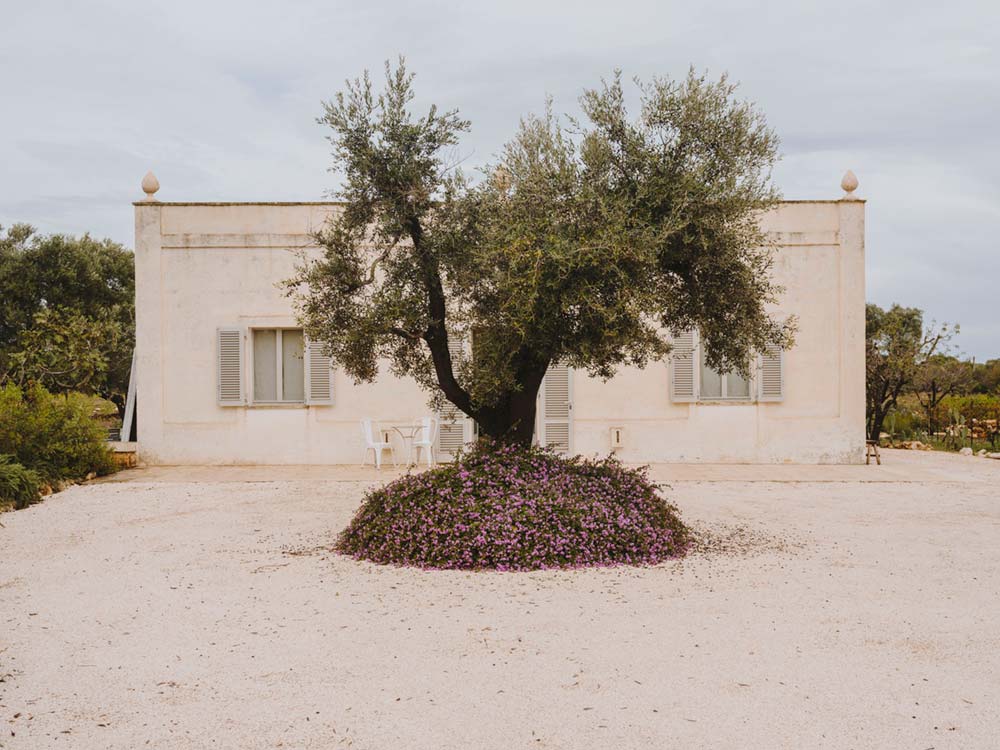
[336,441,690,570]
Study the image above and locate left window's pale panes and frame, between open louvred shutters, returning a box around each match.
[252,328,306,404]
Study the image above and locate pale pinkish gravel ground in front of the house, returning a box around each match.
[0,458,1000,750]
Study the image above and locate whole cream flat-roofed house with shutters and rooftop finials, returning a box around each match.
[134,172,865,464]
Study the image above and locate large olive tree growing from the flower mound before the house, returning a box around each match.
[289,60,794,443]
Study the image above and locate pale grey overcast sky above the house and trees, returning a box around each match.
[0,0,1000,360]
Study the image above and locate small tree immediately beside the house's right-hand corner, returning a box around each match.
[865,304,959,440]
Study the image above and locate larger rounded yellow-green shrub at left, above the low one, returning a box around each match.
[0,385,115,485]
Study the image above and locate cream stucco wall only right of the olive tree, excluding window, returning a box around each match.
[573,201,865,463]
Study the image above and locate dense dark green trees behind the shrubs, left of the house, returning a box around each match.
[0,224,135,418]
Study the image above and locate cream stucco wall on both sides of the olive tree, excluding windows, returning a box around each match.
[135,195,864,464]
